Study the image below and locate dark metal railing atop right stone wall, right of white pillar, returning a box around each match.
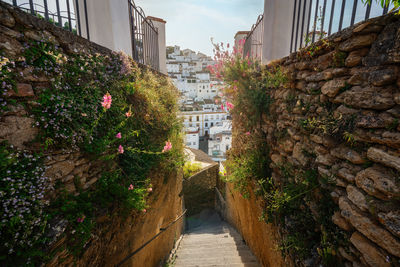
[290,0,392,52]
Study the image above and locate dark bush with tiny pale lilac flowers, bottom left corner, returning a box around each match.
[0,142,50,265]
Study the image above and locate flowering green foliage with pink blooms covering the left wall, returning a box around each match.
[0,42,183,265]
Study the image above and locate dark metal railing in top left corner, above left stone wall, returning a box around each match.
[2,0,90,40]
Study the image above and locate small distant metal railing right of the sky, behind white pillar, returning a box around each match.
[243,15,264,59]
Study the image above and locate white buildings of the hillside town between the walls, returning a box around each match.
[167,46,232,161]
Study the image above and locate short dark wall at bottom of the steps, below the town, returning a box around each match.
[183,163,219,216]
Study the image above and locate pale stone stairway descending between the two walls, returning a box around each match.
[174,210,260,267]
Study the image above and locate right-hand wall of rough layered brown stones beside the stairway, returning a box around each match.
[227,12,400,266]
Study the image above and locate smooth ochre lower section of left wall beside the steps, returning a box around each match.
[46,173,184,267]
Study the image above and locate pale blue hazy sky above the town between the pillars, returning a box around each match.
[135,0,264,56]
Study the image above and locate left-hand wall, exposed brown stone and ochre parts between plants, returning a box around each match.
[0,1,183,266]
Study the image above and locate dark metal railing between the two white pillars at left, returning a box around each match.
[128,0,160,70]
